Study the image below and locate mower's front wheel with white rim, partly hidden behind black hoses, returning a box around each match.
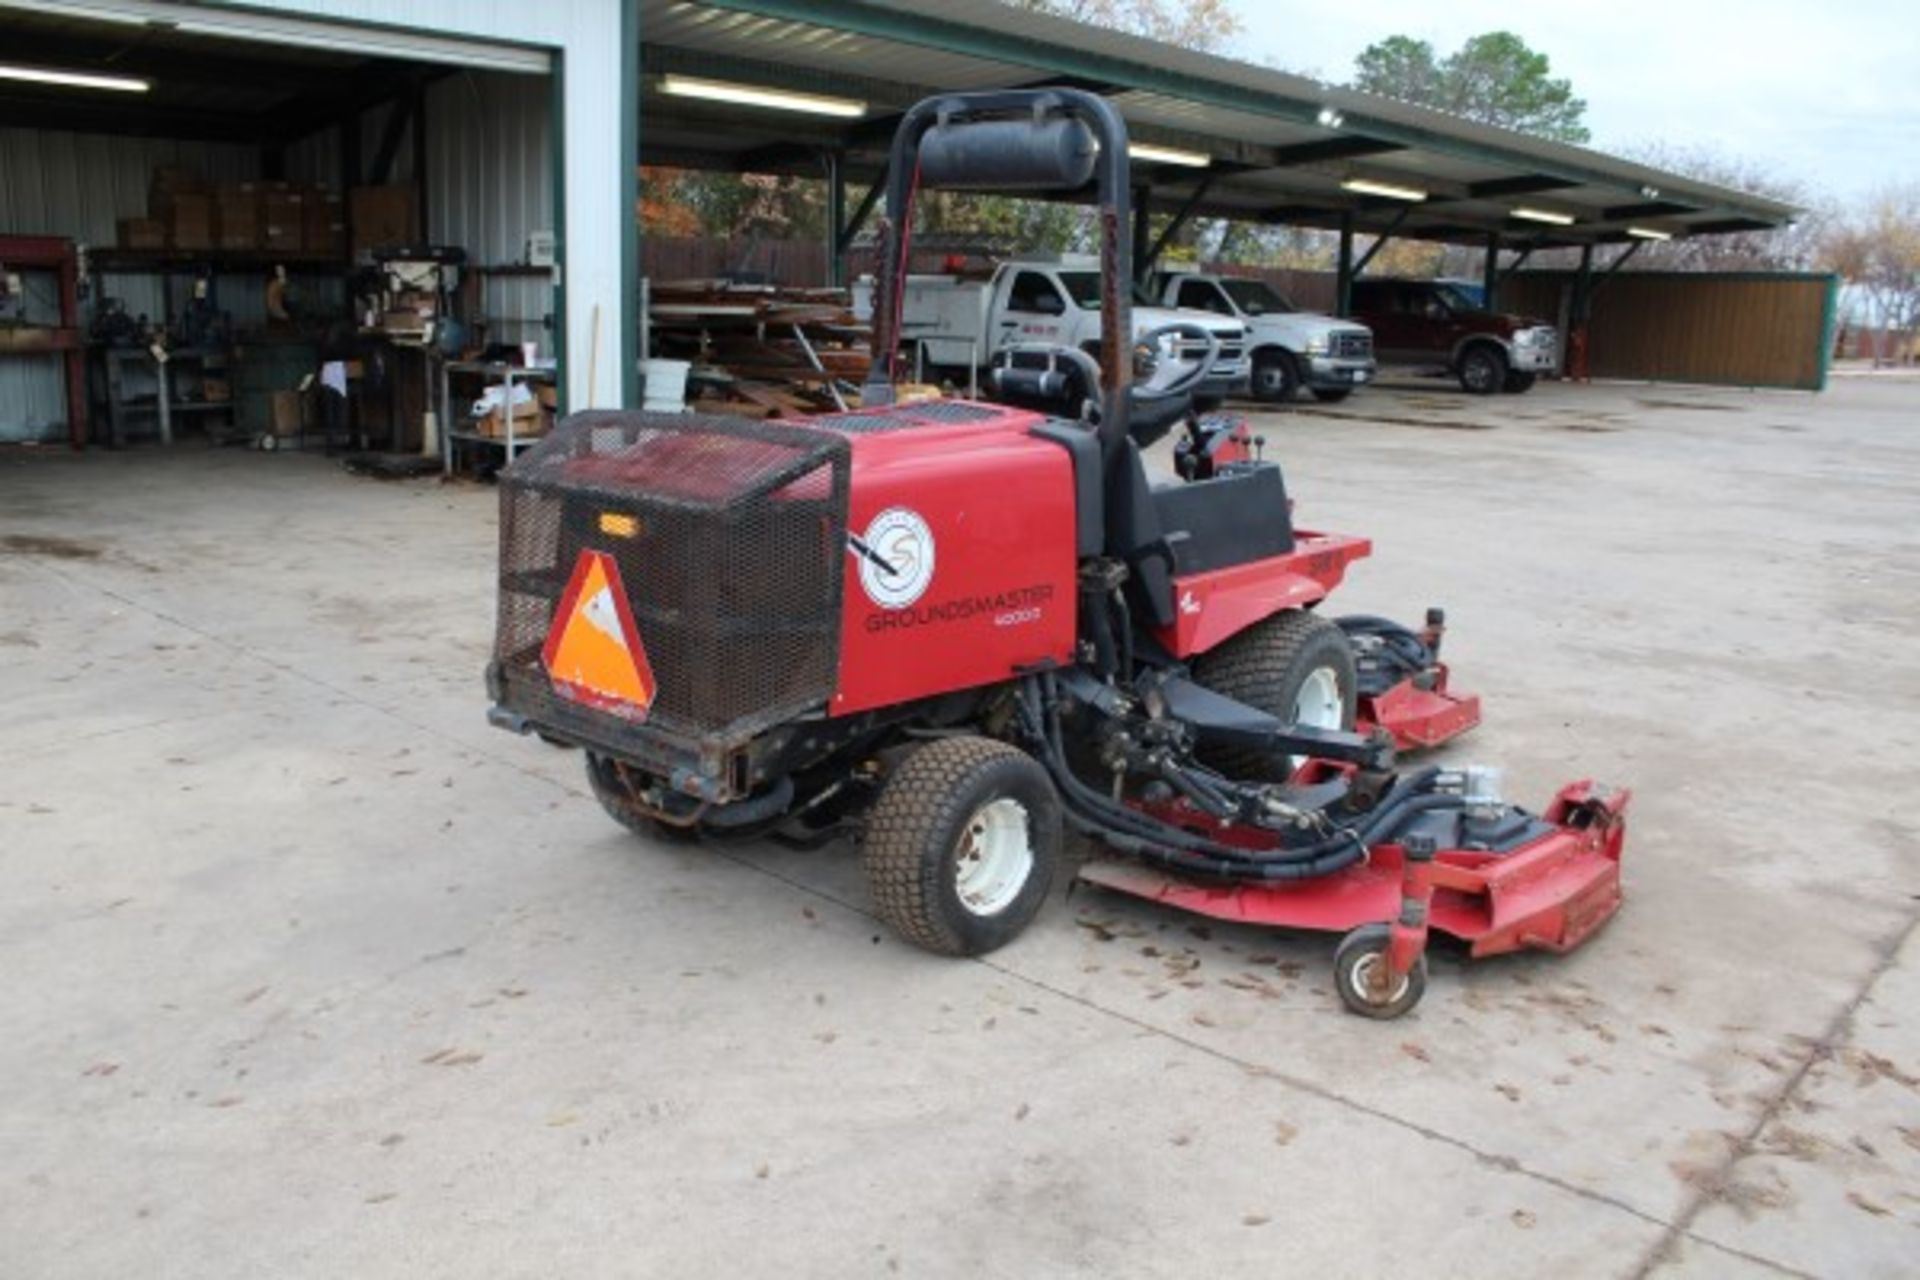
[1194,608,1359,783]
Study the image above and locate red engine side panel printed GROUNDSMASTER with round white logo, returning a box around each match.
[818,401,1079,716]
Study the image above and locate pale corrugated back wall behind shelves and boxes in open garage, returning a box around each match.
[0,129,263,441]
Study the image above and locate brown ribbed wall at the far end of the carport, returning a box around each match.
[1500,271,1836,391]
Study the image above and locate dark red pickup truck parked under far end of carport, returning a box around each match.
[1352,280,1559,395]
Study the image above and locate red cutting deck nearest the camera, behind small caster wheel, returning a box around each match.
[1079,783,1630,956]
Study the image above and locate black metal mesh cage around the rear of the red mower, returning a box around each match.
[493,413,851,745]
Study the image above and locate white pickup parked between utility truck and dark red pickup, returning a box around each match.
[1152,271,1375,403]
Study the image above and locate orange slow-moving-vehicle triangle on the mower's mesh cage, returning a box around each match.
[541,551,657,720]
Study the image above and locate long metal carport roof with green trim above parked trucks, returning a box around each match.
[639,0,1799,248]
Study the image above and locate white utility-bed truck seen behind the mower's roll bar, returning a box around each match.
[900,257,1252,403]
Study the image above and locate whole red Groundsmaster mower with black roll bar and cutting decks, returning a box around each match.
[488,90,1626,1017]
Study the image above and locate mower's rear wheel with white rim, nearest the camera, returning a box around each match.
[866,737,1060,956]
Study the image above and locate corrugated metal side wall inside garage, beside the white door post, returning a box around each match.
[426,71,555,351]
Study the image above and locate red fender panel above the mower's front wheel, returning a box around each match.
[1156,532,1373,658]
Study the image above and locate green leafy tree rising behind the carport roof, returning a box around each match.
[1354,31,1592,142]
